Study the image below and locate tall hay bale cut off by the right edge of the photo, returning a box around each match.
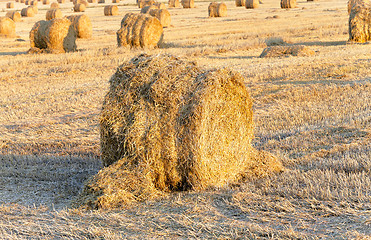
[349,2,371,43]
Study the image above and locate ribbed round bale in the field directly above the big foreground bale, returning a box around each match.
[116,13,163,48]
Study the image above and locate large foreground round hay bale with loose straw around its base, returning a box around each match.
[76,55,282,208]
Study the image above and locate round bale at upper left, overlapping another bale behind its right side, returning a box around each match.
[29,18,76,53]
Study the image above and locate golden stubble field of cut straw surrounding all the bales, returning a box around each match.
[0,0,371,239]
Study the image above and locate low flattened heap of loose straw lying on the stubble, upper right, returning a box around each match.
[259,45,314,58]
